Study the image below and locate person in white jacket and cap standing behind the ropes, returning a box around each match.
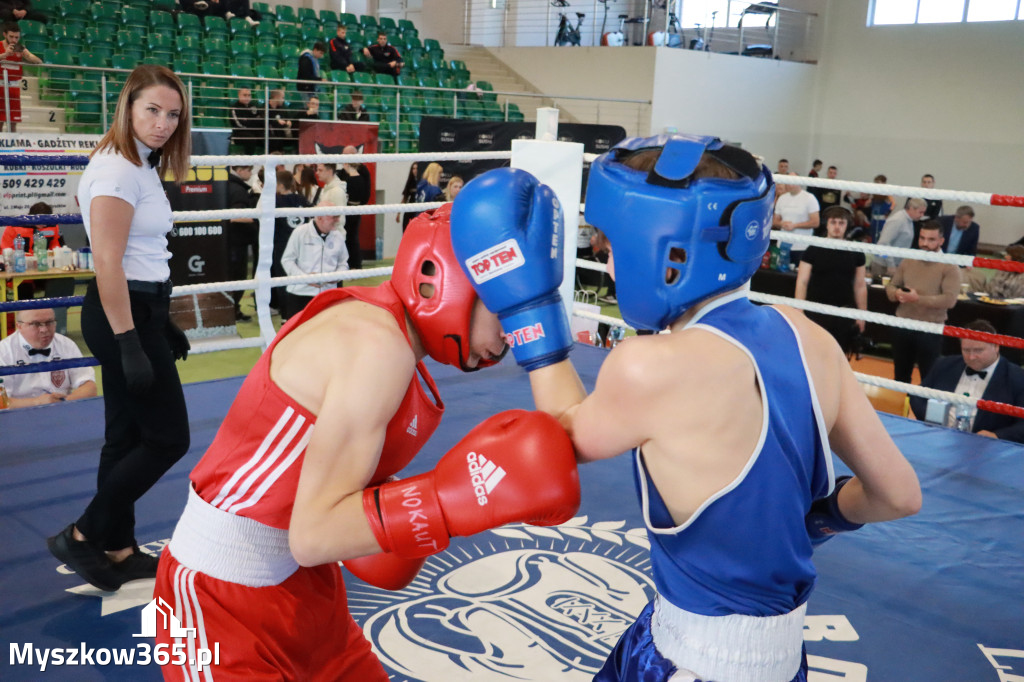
[281,201,348,319]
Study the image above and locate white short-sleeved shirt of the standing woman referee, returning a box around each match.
[78,139,174,282]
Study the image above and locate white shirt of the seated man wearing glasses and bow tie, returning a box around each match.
[0,332,96,398]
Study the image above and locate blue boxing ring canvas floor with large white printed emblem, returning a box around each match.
[0,346,1024,682]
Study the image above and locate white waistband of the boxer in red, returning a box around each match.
[169,485,299,587]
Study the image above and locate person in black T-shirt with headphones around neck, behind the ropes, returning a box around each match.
[794,206,867,354]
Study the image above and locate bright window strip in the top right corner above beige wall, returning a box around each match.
[867,0,1024,26]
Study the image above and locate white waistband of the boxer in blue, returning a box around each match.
[650,597,807,682]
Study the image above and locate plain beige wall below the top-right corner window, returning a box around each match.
[815,0,1024,244]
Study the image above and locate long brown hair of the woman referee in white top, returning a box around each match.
[89,63,191,184]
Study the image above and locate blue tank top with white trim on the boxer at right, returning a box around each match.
[634,292,834,616]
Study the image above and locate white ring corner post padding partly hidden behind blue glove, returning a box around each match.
[512,139,583,329]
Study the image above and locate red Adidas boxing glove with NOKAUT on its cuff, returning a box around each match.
[362,410,580,558]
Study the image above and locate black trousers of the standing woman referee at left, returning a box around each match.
[76,282,189,551]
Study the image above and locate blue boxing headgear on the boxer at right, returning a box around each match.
[586,135,775,330]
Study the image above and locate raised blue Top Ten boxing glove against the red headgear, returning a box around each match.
[452,168,572,372]
